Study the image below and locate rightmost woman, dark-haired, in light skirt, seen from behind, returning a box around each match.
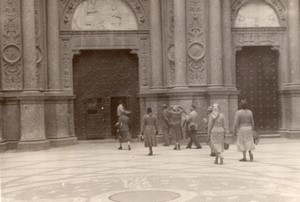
[233,100,255,161]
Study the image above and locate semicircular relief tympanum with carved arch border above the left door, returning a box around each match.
[60,0,149,31]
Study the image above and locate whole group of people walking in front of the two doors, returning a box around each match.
[117,100,255,164]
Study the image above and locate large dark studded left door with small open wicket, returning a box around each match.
[73,50,140,139]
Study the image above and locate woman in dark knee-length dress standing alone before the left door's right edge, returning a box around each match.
[142,107,158,156]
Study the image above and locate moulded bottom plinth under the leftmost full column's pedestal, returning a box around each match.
[17,140,50,151]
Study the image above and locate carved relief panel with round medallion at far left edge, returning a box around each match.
[0,0,23,90]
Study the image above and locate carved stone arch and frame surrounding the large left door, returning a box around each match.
[60,0,150,139]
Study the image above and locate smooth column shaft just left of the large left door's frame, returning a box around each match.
[47,0,62,91]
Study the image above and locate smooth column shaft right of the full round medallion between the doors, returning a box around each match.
[209,0,223,87]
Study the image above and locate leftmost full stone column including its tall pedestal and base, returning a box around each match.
[17,0,50,150]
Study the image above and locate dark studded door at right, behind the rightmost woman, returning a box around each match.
[236,46,279,133]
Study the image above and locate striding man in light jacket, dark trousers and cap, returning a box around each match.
[184,105,202,149]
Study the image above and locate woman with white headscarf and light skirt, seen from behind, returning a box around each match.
[208,103,226,165]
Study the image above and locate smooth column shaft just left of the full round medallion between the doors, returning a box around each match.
[174,0,187,87]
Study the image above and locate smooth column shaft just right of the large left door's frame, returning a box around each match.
[150,0,163,89]
